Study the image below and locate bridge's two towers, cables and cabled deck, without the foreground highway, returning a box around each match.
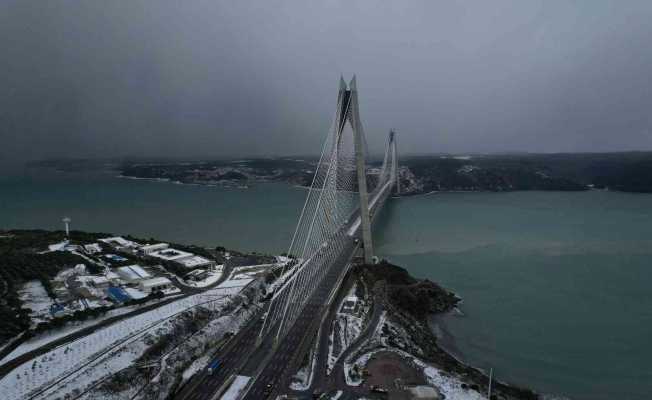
[259,77,397,344]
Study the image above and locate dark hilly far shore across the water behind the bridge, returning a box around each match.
[28,152,652,196]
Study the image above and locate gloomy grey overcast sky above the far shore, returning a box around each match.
[0,0,652,165]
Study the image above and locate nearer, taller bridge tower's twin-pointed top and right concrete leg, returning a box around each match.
[336,75,374,264]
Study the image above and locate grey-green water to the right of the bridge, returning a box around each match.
[376,192,652,399]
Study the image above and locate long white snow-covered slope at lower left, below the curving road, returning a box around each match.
[0,279,252,400]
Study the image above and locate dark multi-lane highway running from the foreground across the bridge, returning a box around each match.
[174,173,392,400]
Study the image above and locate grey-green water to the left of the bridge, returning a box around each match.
[0,170,305,254]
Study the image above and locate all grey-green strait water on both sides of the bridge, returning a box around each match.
[0,171,652,399]
